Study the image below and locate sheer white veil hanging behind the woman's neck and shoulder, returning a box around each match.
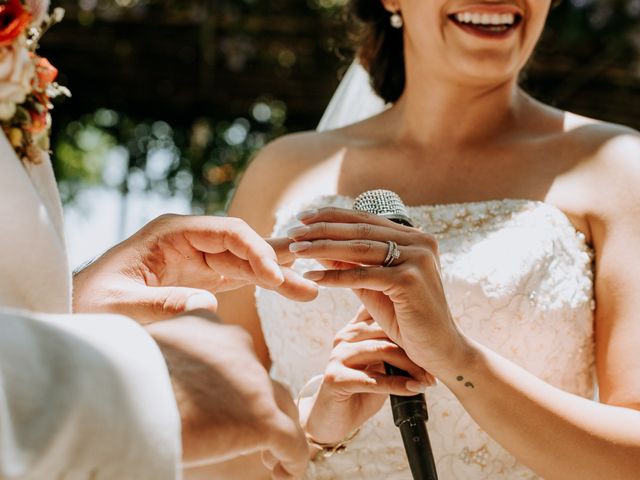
[317,61,387,132]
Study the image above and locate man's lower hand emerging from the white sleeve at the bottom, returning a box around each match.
[145,311,308,479]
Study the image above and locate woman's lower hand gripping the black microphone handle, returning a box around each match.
[301,308,435,444]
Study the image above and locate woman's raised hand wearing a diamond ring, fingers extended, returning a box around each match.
[289,208,472,376]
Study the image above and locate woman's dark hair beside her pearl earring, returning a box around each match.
[348,0,562,103]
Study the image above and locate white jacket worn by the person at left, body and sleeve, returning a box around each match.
[0,131,181,480]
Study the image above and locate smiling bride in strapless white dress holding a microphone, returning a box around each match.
[215,0,640,480]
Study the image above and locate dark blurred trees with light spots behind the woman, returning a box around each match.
[43,0,640,212]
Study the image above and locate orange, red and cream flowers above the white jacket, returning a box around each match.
[0,0,70,164]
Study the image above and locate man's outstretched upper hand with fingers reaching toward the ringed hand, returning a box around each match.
[73,215,317,322]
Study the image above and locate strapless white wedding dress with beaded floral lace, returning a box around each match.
[256,196,595,480]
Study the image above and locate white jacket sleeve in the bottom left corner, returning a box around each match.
[0,310,181,480]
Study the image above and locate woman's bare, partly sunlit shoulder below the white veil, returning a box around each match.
[228,132,344,236]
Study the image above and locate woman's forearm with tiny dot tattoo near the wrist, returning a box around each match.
[440,338,640,480]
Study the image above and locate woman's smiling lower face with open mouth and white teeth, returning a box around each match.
[392,0,551,83]
